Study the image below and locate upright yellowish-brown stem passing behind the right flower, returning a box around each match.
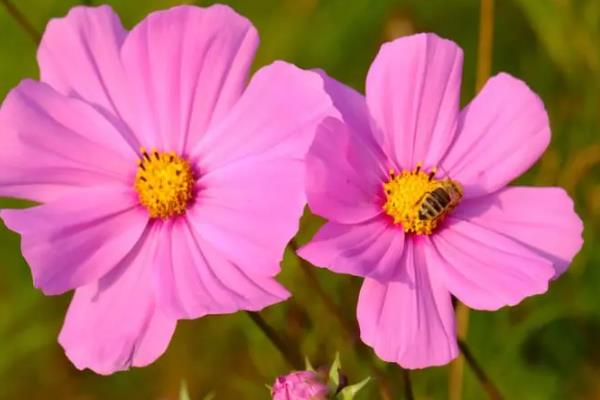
[448,0,494,400]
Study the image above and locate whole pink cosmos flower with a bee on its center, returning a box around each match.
[299,34,582,368]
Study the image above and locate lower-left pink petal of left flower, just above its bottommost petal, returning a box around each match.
[0,187,148,294]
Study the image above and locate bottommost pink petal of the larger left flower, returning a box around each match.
[59,231,176,374]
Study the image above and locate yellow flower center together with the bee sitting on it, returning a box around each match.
[383,164,463,235]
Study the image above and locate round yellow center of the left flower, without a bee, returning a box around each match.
[135,148,195,219]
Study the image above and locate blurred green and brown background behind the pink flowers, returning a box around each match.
[0,0,600,399]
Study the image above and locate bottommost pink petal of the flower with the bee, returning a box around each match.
[357,238,458,369]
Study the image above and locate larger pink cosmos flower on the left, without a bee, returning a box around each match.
[0,6,330,374]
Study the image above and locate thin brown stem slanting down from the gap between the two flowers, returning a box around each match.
[290,239,396,400]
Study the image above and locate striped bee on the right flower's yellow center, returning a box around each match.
[415,178,463,221]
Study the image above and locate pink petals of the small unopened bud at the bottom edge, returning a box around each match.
[271,371,329,400]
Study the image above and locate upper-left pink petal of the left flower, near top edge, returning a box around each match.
[38,6,140,150]
